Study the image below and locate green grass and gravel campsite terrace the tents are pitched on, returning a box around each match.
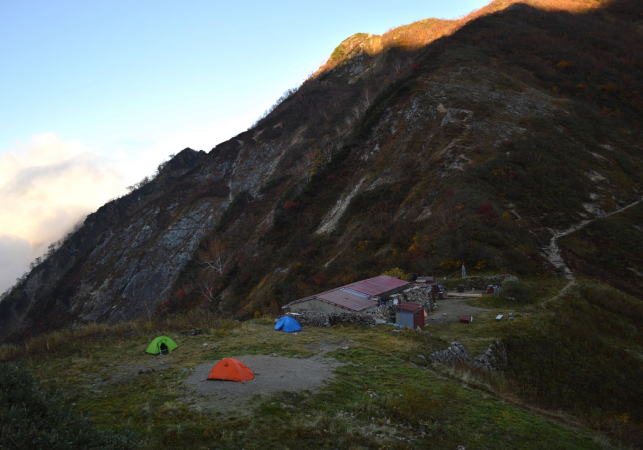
[0,296,620,449]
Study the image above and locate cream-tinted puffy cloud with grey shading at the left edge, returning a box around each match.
[0,133,124,291]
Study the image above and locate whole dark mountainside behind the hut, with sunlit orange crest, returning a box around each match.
[0,0,643,339]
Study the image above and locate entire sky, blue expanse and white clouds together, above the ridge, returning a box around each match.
[0,0,488,292]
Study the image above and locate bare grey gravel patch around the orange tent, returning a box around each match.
[186,355,340,414]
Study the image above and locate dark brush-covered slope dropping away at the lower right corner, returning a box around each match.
[502,284,643,447]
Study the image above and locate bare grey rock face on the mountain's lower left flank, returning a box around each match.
[0,149,221,338]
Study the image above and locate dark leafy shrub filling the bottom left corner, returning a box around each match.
[0,364,134,449]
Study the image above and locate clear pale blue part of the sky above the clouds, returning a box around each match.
[0,0,487,157]
